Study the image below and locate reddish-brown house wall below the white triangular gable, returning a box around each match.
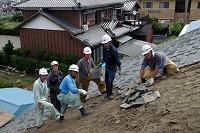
[20,29,85,58]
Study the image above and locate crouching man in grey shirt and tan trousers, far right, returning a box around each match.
[139,45,179,86]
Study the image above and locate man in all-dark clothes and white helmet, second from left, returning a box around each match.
[47,61,64,112]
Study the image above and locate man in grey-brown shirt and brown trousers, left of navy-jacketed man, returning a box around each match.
[77,47,106,102]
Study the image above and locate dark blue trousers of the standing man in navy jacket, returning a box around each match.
[105,68,116,97]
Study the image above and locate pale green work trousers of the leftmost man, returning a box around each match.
[36,101,60,127]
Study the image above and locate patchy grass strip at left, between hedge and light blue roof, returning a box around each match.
[0,72,38,91]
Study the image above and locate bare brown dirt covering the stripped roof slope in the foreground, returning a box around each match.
[24,63,200,133]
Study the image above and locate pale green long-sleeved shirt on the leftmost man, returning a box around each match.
[33,78,48,106]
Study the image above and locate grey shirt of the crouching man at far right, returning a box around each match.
[141,52,169,70]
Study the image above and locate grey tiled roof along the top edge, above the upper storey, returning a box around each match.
[15,0,131,8]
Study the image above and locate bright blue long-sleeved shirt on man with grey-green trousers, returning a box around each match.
[59,74,79,94]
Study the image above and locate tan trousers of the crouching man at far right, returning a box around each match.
[143,60,179,80]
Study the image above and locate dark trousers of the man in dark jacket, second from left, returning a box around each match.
[50,90,61,112]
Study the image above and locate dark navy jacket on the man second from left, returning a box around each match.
[47,71,64,93]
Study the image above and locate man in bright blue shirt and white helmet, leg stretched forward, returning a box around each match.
[57,64,92,122]
